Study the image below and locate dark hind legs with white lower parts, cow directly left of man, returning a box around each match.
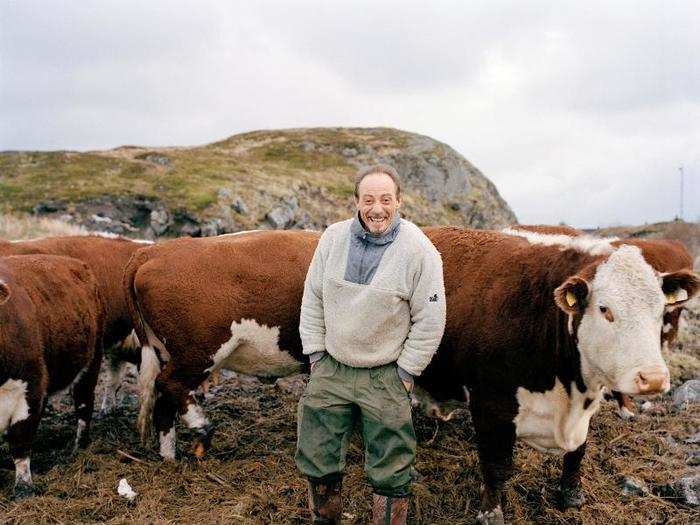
[153,361,214,459]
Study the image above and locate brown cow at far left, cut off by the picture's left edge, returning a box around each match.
[0,255,105,498]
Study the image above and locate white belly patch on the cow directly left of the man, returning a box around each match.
[205,319,301,377]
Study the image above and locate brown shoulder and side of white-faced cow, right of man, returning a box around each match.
[421,227,598,398]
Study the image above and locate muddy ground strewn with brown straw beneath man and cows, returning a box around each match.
[0,304,700,524]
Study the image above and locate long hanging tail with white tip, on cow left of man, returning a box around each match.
[124,247,160,443]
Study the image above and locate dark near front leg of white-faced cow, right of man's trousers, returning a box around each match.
[470,395,515,525]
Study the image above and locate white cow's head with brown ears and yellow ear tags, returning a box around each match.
[554,246,700,394]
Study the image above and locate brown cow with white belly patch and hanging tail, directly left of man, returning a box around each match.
[124,231,319,459]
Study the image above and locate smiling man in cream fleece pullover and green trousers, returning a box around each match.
[296,164,445,525]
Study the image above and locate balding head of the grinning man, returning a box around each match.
[355,164,401,235]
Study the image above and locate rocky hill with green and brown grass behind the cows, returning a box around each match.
[0,128,516,237]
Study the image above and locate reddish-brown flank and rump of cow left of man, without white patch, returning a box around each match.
[134,231,319,357]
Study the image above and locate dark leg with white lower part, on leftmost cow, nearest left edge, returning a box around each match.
[7,397,44,500]
